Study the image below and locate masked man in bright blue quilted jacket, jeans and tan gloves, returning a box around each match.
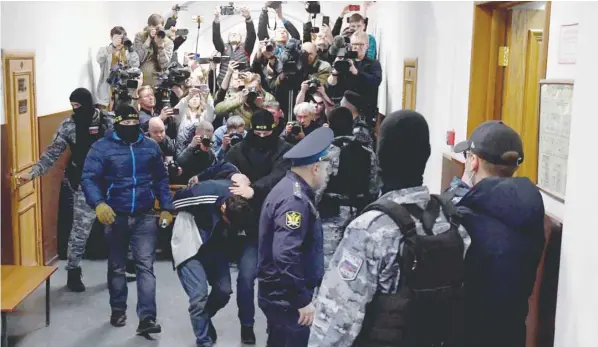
[81,105,173,334]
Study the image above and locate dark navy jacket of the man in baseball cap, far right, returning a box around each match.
[453,177,544,347]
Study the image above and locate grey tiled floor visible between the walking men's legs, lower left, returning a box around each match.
[7,261,266,347]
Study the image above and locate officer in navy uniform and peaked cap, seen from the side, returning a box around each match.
[258,128,333,347]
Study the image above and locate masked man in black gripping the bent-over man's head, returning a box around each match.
[225,109,291,344]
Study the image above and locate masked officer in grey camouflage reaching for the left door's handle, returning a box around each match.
[18,88,113,292]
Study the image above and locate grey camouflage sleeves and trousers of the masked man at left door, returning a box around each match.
[30,110,112,270]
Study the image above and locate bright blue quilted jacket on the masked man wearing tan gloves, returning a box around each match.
[81,131,173,215]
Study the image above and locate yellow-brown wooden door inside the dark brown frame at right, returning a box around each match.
[500,7,546,182]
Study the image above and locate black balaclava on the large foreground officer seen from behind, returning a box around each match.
[378,110,431,194]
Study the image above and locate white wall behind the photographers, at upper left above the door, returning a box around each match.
[0,1,345,123]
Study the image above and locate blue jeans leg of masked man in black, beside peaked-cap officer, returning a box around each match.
[237,241,257,327]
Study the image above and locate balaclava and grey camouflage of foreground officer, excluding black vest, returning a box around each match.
[309,111,470,347]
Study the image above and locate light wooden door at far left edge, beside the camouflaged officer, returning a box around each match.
[2,51,44,265]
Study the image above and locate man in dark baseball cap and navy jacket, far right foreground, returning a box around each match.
[454,121,544,347]
